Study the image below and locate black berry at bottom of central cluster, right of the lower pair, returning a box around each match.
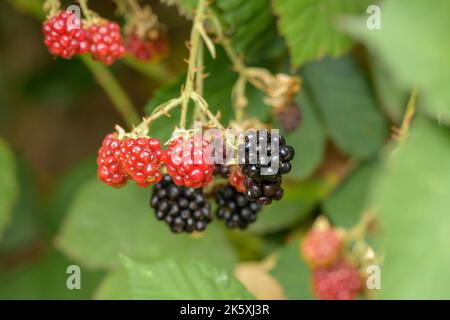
[214,185,261,229]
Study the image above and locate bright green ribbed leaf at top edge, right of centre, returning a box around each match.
[273,0,368,67]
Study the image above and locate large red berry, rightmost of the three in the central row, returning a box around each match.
[165,136,214,188]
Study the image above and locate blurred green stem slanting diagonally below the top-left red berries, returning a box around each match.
[81,56,139,126]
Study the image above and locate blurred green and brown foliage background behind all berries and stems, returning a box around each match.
[0,0,450,299]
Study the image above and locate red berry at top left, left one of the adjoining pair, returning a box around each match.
[42,11,89,59]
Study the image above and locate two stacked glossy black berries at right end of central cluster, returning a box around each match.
[238,130,295,204]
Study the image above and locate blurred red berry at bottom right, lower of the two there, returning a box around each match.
[312,261,363,300]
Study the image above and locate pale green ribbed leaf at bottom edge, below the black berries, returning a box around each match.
[122,257,252,300]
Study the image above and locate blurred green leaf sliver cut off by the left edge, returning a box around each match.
[0,139,19,235]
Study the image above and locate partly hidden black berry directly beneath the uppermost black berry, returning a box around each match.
[244,178,284,205]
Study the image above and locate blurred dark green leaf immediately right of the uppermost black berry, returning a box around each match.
[283,90,327,179]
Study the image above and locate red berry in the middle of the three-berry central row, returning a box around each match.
[120,137,164,188]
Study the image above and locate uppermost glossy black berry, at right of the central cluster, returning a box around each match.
[238,130,295,182]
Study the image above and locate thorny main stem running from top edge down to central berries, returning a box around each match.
[180,0,207,129]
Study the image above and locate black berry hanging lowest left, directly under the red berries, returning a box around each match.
[150,174,212,233]
